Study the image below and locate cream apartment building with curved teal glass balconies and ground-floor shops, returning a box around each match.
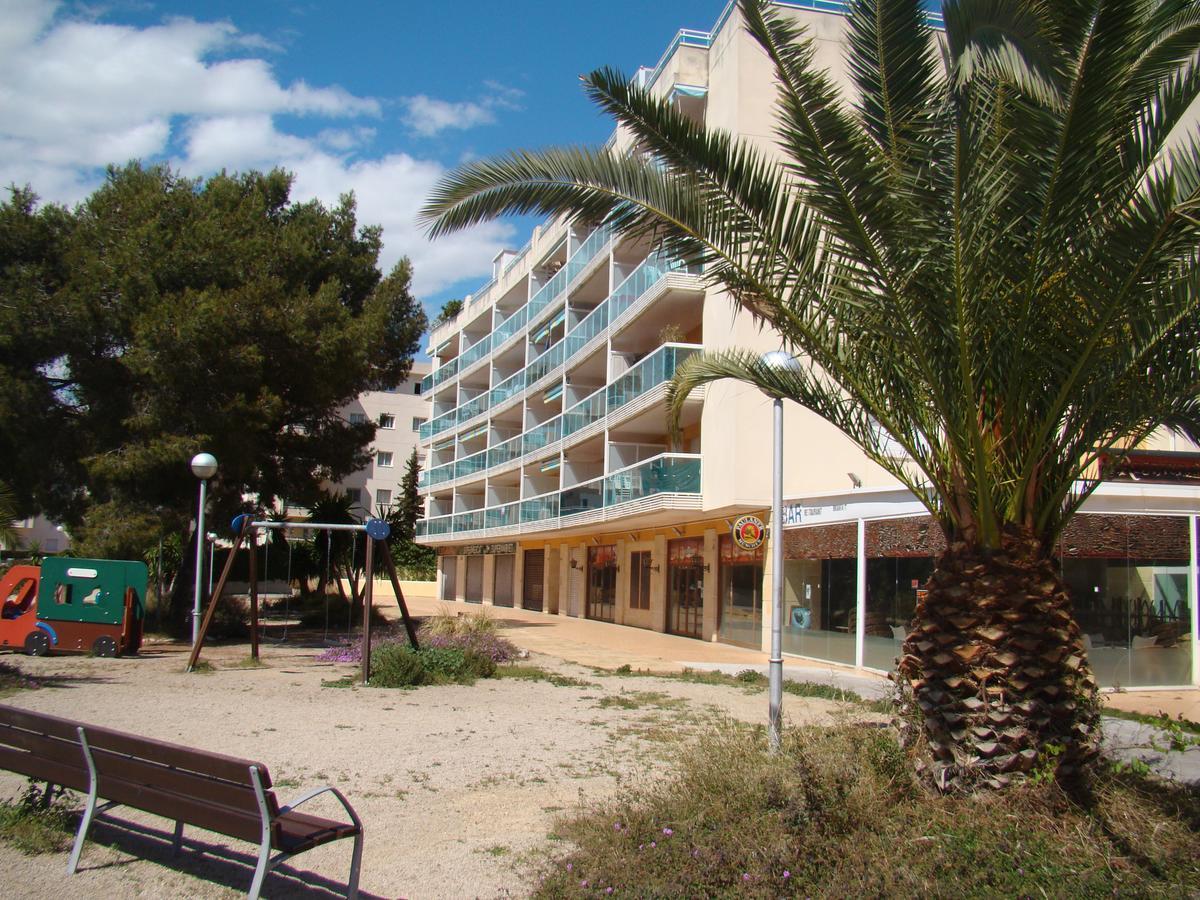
[418,0,1200,688]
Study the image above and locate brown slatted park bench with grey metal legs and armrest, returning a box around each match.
[0,704,362,900]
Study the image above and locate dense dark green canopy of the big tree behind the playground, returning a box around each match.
[0,163,426,553]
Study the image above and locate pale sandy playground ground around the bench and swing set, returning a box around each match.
[0,641,864,900]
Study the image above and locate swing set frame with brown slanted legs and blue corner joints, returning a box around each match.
[187,515,418,684]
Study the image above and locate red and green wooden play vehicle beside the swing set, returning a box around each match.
[0,557,146,656]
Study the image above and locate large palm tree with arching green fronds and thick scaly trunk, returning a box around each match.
[426,0,1200,787]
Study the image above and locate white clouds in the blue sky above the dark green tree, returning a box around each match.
[0,0,511,303]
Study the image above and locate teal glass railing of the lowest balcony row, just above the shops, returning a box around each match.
[416,454,701,538]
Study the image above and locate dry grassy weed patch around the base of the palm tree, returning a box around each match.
[534,724,1200,898]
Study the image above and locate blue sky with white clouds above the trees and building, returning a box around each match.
[0,0,945,324]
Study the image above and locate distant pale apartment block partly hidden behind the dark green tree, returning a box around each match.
[332,362,431,516]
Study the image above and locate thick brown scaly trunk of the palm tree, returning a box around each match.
[896,532,1099,790]
